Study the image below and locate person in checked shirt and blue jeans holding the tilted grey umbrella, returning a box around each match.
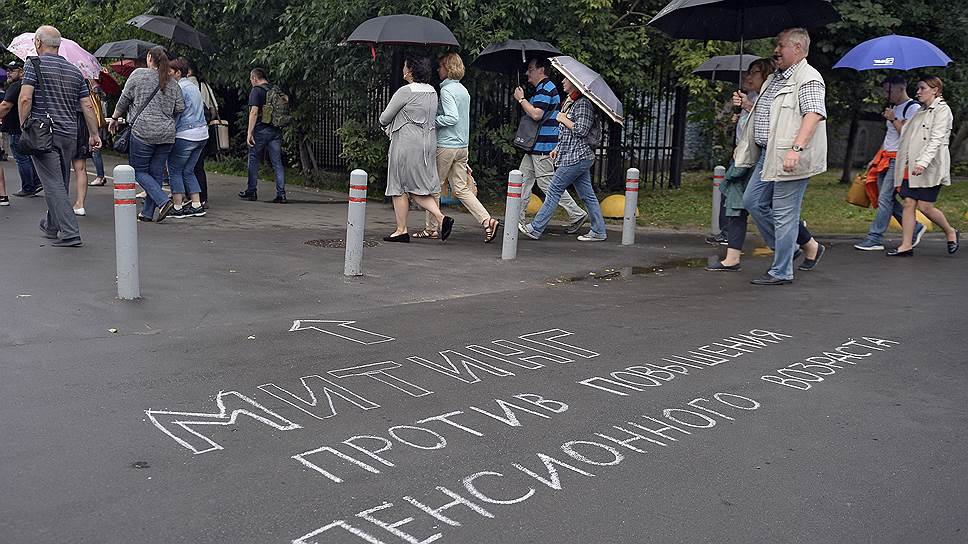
[518,77,607,242]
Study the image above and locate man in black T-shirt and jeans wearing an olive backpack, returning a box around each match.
[239,68,288,204]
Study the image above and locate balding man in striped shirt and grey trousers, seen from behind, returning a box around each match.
[18,26,101,247]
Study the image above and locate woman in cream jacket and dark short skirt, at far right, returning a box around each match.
[887,76,961,257]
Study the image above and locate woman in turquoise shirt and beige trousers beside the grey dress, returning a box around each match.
[422,53,500,243]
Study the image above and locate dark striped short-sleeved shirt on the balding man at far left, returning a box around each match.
[23,54,91,138]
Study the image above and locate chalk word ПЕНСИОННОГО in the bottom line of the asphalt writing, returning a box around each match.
[292,393,760,544]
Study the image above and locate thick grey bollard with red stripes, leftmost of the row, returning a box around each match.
[114,164,141,300]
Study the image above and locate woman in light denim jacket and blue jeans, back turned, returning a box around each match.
[168,58,208,219]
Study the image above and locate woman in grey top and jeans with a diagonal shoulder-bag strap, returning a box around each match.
[108,47,185,222]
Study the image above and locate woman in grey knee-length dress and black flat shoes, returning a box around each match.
[380,57,454,243]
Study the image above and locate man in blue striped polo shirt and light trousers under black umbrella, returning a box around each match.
[512,59,588,234]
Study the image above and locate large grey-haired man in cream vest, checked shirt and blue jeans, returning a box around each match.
[735,28,827,285]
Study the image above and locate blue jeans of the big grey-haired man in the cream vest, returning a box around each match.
[743,150,810,280]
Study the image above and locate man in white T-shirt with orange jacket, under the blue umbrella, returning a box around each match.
[854,76,927,251]
